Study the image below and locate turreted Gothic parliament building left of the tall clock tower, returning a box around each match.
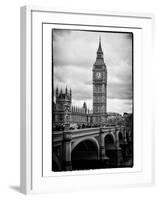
[53,88,92,128]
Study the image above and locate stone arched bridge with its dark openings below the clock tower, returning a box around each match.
[52,126,133,171]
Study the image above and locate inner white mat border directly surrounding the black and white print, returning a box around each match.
[43,24,142,176]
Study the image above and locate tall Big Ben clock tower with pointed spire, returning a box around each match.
[92,38,107,125]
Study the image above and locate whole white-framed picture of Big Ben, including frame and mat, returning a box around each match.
[21,7,154,193]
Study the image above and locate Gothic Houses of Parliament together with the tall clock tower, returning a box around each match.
[53,39,107,128]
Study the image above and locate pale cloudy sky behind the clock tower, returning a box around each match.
[53,29,133,114]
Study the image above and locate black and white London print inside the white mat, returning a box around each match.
[50,29,134,172]
